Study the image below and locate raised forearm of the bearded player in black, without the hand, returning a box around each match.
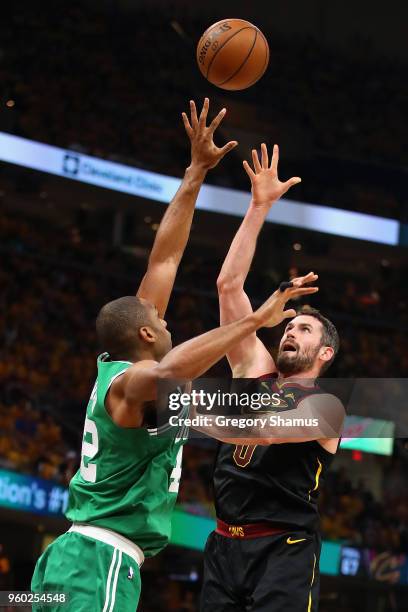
[218,202,269,289]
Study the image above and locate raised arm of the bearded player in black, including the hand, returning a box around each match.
[217,144,301,378]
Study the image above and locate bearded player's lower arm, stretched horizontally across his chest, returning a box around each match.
[190,393,345,446]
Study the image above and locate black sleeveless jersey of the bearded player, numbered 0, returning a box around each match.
[214,380,334,530]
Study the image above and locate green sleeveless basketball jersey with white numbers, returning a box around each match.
[66,353,186,557]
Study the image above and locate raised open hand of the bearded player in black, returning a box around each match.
[243,143,302,207]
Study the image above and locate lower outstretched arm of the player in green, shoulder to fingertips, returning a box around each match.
[108,277,318,427]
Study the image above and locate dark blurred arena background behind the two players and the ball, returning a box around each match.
[0,0,408,612]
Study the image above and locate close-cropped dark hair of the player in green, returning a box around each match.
[96,296,151,359]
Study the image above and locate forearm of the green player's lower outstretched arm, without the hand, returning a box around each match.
[157,313,262,379]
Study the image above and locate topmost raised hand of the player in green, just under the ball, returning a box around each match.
[182,98,238,170]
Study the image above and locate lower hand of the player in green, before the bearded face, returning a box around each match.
[255,272,319,327]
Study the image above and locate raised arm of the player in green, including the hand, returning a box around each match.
[137,98,238,318]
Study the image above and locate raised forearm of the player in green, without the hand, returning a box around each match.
[149,164,207,266]
